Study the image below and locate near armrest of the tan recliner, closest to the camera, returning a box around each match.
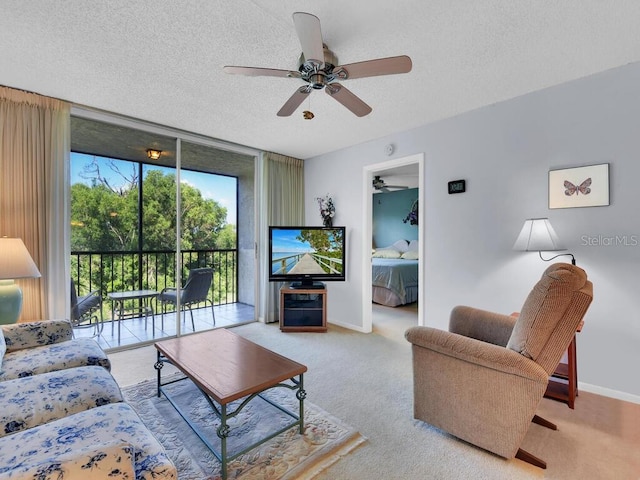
[405,327,549,385]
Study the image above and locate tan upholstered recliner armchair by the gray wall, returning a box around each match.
[405,263,593,468]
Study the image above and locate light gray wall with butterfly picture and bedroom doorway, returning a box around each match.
[305,64,640,401]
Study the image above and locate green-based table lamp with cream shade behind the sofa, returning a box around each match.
[0,237,40,325]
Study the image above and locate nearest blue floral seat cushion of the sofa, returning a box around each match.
[0,403,177,480]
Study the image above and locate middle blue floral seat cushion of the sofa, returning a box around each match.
[0,366,122,437]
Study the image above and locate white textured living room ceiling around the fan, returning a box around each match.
[0,0,640,158]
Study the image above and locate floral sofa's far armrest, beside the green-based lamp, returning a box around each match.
[2,320,73,352]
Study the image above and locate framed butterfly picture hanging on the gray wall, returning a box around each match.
[549,163,609,208]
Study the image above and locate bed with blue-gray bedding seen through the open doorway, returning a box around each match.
[371,242,418,307]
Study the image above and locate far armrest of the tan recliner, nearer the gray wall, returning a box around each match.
[449,306,517,347]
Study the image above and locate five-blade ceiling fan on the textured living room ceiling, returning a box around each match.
[224,12,412,117]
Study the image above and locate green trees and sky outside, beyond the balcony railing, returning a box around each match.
[71,155,236,310]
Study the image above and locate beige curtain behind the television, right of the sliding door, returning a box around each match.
[264,153,304,322]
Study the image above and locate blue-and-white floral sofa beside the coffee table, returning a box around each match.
[0,320,177,480]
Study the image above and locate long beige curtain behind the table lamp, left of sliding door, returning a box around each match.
[0,87,70,322]
